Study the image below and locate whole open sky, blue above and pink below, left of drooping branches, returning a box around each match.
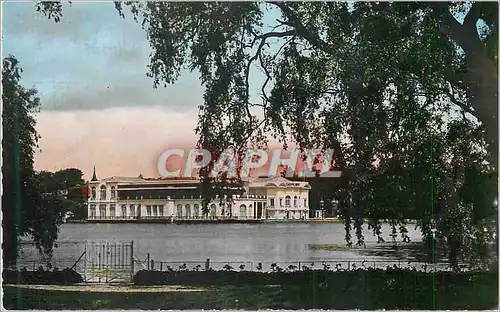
[2,1,284,179]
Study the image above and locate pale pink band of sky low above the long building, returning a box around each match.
[35,108,316,179]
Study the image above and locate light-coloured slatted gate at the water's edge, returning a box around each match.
[83,241,134,283]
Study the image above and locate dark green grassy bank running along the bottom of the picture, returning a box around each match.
[4,273,498,310]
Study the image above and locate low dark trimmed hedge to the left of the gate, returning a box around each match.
[2,268,83,285]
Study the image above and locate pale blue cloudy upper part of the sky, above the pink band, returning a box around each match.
[3,2,202,111]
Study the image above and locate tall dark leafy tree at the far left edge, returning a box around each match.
[2,56,66,265]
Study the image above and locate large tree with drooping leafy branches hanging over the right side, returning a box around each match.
[37,2,498,266]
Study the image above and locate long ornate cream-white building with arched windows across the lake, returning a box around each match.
[87,169,310,222]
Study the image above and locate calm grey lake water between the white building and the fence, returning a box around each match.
[20,222,421,267]
